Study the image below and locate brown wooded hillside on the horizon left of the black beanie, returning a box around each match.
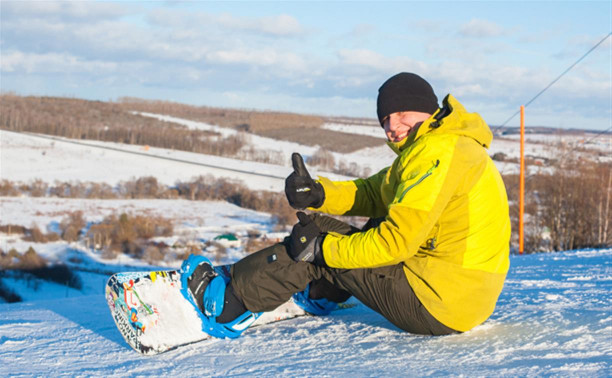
[0,94,384,157]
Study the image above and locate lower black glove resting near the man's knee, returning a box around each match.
[286,211,327,266]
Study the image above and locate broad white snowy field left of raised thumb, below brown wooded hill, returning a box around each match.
[0,130,348,192]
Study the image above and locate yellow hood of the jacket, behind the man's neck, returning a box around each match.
[387,94,493,154]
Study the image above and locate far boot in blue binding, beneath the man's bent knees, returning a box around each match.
[293,279,351,316]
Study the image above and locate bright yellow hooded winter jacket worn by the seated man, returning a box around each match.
[315,95,510,331]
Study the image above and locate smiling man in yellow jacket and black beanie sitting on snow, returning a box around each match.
[184,73,510,337]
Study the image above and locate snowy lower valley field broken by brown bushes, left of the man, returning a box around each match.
[0,197,285,270]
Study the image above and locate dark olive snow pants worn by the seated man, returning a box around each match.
[231,214,457,335]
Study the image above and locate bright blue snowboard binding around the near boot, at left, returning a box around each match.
[181,255,261,339]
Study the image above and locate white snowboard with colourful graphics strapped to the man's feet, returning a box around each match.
[105,265,354,355]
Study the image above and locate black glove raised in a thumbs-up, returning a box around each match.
[285,152,325,210]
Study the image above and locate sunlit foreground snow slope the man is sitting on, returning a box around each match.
[0,249,612,377]
